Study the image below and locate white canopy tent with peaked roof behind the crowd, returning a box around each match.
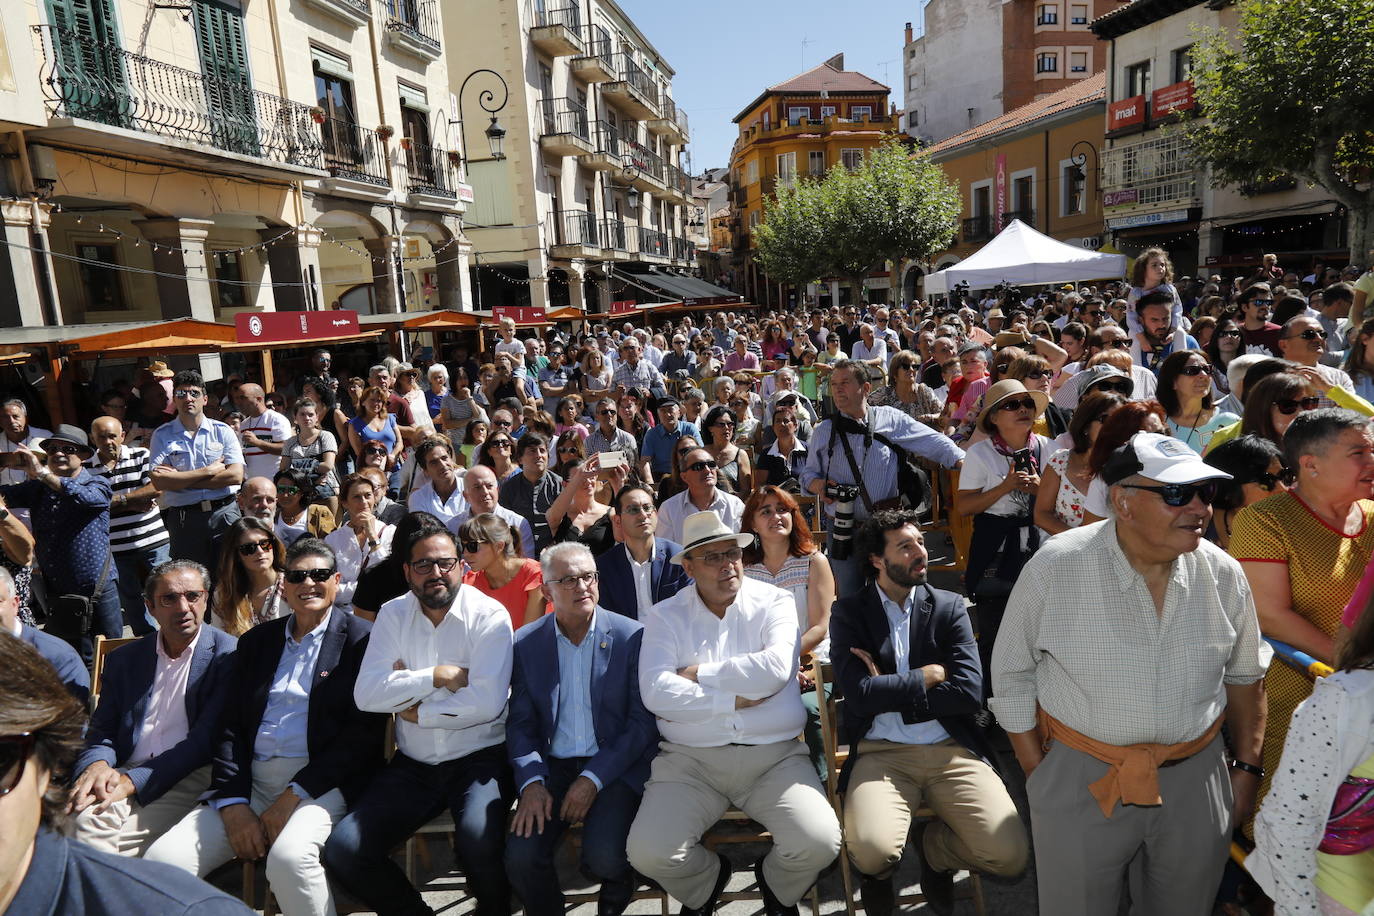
[926,220,1125,294]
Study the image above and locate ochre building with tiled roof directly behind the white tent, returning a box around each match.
[923,71,1106,299]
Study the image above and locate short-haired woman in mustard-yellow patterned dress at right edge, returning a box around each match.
[1230,409,1374,823]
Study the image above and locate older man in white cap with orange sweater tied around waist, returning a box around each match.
[989,433,1272,913]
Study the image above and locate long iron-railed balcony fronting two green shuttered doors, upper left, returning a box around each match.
[34,26,324,179]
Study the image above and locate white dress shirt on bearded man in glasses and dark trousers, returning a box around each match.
[353,585,515,764]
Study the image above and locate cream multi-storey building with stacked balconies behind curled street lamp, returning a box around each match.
[445,0,695,312]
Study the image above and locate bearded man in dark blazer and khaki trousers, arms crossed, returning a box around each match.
[830,509,1029,916]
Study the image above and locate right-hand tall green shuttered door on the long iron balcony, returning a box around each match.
[191,0,261,155]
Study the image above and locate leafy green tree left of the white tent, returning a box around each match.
[754,137,960,302]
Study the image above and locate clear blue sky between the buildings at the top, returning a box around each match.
[620,0,923,174]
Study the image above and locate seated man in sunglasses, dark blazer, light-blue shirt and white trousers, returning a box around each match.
[146,537,386,916]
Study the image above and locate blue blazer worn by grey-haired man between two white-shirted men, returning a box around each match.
[506,607,658,794]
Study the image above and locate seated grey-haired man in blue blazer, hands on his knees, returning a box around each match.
[506,541,658,916]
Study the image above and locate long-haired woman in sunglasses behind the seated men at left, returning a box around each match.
[210,516,290,636]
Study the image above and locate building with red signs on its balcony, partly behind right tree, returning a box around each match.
[1092,0,1349,276]
